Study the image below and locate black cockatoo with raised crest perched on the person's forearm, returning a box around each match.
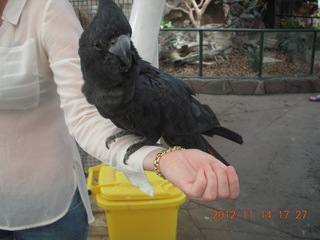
[79,0,242,165]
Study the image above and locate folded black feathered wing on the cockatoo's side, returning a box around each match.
[129,62,201,142]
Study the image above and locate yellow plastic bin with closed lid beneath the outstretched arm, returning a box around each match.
[87,164,186,240]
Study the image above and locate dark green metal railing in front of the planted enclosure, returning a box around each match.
[160,28,320,78]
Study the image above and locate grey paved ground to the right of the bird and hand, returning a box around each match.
[178,94,320,240]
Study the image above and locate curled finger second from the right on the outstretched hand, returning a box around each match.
[211,163,230,199]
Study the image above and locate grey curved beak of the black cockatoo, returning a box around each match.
[109,35,132,72]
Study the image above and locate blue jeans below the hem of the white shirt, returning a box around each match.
[0,191,88,240]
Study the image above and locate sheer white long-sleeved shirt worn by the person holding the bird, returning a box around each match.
[0,0,159,230]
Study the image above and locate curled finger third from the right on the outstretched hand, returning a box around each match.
[200,165,218,202]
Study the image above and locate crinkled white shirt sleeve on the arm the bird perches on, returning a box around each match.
[41,0,159,195]
